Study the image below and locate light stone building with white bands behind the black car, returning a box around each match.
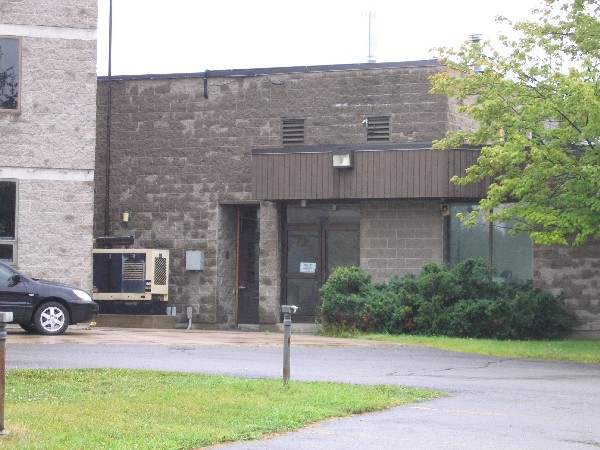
[0,0,97,289]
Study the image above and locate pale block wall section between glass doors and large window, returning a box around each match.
[360,200,444,282]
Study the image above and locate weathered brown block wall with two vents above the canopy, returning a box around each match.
[94,65,447,325]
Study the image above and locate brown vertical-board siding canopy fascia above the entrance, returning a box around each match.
[252,150,489,200]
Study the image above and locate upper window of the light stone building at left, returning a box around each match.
[0,37,21,109]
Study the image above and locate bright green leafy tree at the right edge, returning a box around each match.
[431,0,600,245]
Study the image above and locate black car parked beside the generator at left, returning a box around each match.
[0,262,98,335]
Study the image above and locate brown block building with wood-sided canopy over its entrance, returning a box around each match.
[94,61,600,335]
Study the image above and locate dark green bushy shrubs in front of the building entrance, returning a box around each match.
[320,259,575,339]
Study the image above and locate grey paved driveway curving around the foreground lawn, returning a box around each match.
[7,330,600,450]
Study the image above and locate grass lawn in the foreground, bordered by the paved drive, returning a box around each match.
[0,369,441,450]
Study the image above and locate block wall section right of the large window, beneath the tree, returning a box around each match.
[533,241,600,338]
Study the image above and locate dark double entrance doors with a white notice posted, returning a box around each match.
[284,205,359,322]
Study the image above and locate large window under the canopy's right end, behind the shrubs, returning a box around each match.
[449,204,533,282]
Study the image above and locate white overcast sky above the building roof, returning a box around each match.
[98,0,539,75]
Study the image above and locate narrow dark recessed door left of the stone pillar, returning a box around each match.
[237,206,260,324]
